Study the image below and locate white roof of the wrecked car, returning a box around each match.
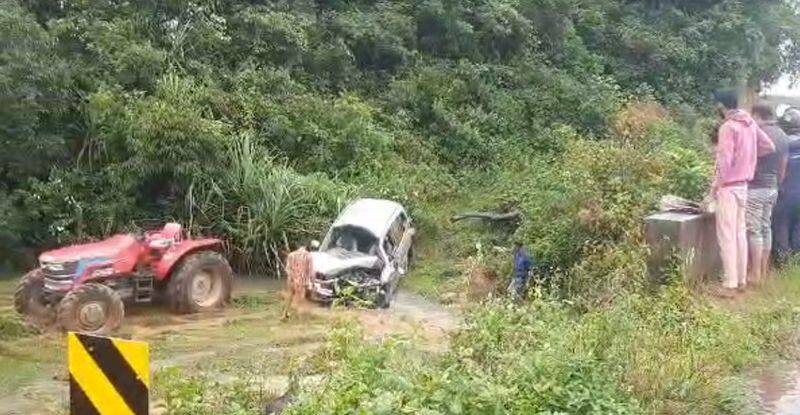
[333,199,405,238]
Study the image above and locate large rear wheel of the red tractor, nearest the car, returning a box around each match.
[167,251,233,314]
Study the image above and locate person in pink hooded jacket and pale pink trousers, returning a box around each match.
[711,92,775,294]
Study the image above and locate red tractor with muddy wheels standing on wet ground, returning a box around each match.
[14,223,233,334]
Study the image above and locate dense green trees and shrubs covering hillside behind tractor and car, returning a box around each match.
[0,0,800,270]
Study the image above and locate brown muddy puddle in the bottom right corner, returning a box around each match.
[758,364,800,415]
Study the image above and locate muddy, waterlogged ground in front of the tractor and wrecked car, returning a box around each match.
[0,278,458,415]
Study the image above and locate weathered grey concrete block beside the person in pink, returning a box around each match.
[645,212,722,282]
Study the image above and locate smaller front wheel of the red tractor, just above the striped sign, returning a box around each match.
[58,284,125,335]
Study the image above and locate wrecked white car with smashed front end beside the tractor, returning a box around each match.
[310,199,415,308]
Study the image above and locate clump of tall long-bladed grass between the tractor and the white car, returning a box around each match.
[187,135,346,275]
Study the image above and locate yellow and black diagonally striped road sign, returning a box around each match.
[67,333,150,415]
